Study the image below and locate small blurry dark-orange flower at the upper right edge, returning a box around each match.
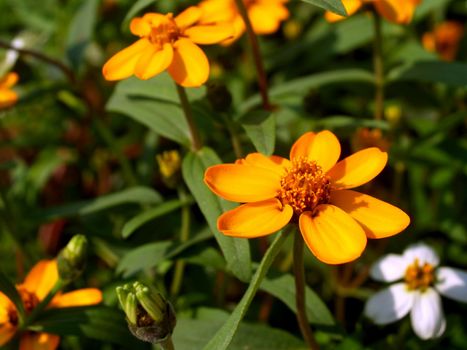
[422,21,464,61]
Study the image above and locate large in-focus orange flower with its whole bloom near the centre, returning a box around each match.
[204,131,410,264]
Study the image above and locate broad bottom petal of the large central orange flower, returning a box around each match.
[299,204,366,264]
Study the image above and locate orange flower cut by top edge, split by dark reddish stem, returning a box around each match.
[198,0,289,45]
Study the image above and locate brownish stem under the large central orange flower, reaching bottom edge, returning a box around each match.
[293,232,319,350]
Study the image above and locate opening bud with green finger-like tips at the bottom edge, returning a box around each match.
[117,282,177,344]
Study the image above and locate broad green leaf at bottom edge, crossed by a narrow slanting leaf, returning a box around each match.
[173,308,306,350]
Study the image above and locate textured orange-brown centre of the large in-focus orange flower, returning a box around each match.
[278,157,331,215]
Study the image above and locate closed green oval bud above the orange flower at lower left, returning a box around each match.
[57,235,88,282]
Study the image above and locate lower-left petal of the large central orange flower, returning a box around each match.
[217,199,293,238]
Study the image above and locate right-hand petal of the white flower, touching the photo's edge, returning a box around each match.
[435,267,467,303]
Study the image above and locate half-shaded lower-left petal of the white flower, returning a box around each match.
[364,283,415,325]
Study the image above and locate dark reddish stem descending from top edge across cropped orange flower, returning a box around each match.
[235,0,272,111]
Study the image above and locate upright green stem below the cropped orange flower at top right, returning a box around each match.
[373,12,384,120]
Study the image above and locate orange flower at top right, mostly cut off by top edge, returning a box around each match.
[325,0,422,24]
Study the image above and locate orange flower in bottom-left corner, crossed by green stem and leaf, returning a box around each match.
[0,260,102,350]
